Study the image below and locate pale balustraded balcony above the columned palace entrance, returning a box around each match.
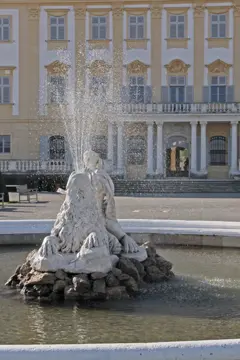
[110,103,240,115]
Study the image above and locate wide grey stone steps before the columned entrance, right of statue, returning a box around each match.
[113,179,240,195]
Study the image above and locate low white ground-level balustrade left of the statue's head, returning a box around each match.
[0,160,73,175]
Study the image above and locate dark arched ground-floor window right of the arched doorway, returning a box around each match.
[210,136,227,165]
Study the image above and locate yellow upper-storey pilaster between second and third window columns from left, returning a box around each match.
[74,5,86,96]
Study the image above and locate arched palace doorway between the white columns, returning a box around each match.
[166,136,189,177]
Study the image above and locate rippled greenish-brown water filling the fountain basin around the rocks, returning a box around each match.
[0,248,240,344]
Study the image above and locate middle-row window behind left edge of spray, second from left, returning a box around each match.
[49,75,66,104]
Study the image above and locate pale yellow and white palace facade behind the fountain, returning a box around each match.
[0,0,240,180]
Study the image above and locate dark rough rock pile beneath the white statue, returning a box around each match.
[5,243,174,303]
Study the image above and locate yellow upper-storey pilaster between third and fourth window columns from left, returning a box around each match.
[112,3,123,102]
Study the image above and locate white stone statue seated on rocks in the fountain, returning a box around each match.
[31,152,147,273]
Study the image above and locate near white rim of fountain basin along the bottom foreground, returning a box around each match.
[0,339,240,360]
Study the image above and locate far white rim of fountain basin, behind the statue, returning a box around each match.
[0,219,240,248]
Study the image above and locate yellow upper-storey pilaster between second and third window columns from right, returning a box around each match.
[151,1,162,103]
